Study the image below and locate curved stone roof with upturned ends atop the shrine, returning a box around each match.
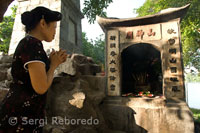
[97,4,190,31]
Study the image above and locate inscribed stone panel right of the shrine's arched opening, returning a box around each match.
[162,21,184,98]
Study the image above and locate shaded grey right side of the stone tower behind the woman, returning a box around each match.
[60,0,83,53]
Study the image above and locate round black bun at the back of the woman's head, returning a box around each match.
[21,11,33,26]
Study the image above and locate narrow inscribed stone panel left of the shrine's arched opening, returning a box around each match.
[107,30,120,96]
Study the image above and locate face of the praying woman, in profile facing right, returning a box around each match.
[43,21,57,42]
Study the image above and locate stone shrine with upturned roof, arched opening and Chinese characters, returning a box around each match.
[97,5,194,133]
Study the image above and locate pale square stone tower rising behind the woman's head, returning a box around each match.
[8,0,83,55]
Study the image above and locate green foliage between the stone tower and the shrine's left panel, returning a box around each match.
[82,32,105,64]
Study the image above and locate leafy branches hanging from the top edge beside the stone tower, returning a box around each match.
[83,0,112,23]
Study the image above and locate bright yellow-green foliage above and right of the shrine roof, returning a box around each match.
[136,0,200,71]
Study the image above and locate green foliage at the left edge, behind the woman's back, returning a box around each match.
[0,6,17,53]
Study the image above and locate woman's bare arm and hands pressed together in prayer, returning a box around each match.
[28,50,67,95]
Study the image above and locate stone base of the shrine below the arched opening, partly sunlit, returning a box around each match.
[100,97,194,133]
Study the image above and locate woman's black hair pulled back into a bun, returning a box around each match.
[21,6,62,33]
